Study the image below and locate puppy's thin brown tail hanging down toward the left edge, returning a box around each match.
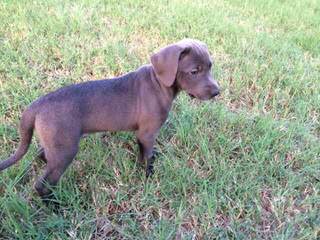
[0,108,35,171]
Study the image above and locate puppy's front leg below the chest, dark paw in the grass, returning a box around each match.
[137,130,157,177]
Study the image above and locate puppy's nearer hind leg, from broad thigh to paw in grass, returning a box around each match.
[35,114,81,202]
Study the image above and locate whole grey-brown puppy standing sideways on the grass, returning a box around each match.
[0,39,219,199]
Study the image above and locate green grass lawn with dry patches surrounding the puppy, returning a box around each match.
[0,0,320,240]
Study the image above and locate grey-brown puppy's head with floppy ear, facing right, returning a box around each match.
[151,39,220,100]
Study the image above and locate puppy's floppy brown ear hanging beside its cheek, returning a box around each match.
[151,43,191,87]
